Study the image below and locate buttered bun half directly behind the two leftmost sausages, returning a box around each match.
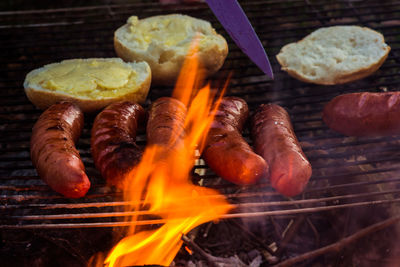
[24,58,151,112]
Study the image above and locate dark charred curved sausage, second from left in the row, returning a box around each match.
[91,101,146,188]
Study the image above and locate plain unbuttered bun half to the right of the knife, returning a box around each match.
[276,26,390,85]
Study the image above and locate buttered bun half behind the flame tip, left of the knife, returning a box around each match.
[114,14,228,85]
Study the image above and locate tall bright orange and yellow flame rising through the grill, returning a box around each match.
[104,38,231,267]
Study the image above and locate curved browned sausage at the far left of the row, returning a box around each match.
[30,102,90,198]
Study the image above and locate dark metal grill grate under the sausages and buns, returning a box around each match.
[0,0,400,263]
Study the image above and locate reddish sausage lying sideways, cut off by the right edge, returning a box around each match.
[322,92,400,136]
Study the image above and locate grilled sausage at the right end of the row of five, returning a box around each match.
[250,104,312,196]
